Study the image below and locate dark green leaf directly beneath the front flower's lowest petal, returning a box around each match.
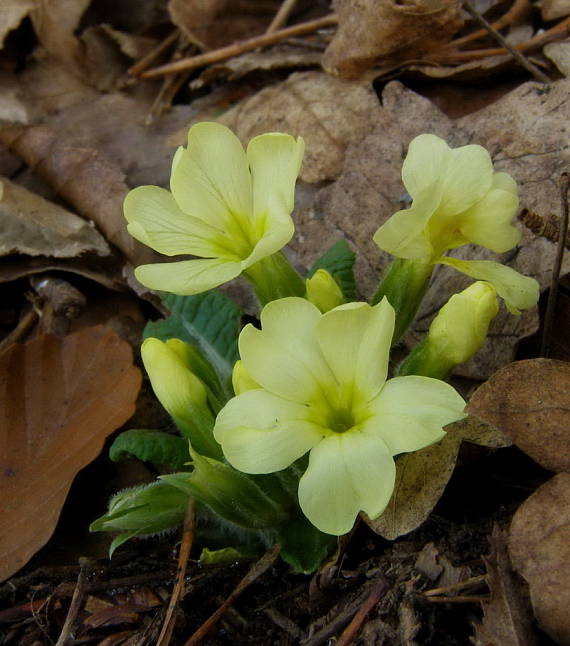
[275,514,337,574]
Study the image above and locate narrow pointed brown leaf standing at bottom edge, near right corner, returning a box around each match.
[473,528,537,646]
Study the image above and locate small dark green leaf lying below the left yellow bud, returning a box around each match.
[109,428,190,470]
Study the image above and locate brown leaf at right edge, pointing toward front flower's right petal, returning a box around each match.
[467,359,570,471]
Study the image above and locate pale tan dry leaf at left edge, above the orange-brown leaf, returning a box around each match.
[0,178,110,258]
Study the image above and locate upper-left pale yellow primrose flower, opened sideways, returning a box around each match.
[124,123,304,295]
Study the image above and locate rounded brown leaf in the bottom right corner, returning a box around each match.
[509,473,570,646]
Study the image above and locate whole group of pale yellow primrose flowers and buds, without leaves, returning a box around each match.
[91,123,538,556]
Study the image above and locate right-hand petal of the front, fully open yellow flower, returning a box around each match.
[365,376,465,455]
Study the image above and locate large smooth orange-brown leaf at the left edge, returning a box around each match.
[0,326,141,580]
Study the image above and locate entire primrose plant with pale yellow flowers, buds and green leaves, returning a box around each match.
[91,123,538,572]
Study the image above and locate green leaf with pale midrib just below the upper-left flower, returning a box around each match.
[144,291,241,396]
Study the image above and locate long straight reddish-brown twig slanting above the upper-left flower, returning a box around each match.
[140,14,338,79]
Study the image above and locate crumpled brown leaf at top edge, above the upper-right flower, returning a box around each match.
[323,0,463,78]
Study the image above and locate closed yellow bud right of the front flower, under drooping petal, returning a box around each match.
[428,281,499,365]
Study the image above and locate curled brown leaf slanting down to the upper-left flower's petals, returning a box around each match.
[0,125,154,264]
